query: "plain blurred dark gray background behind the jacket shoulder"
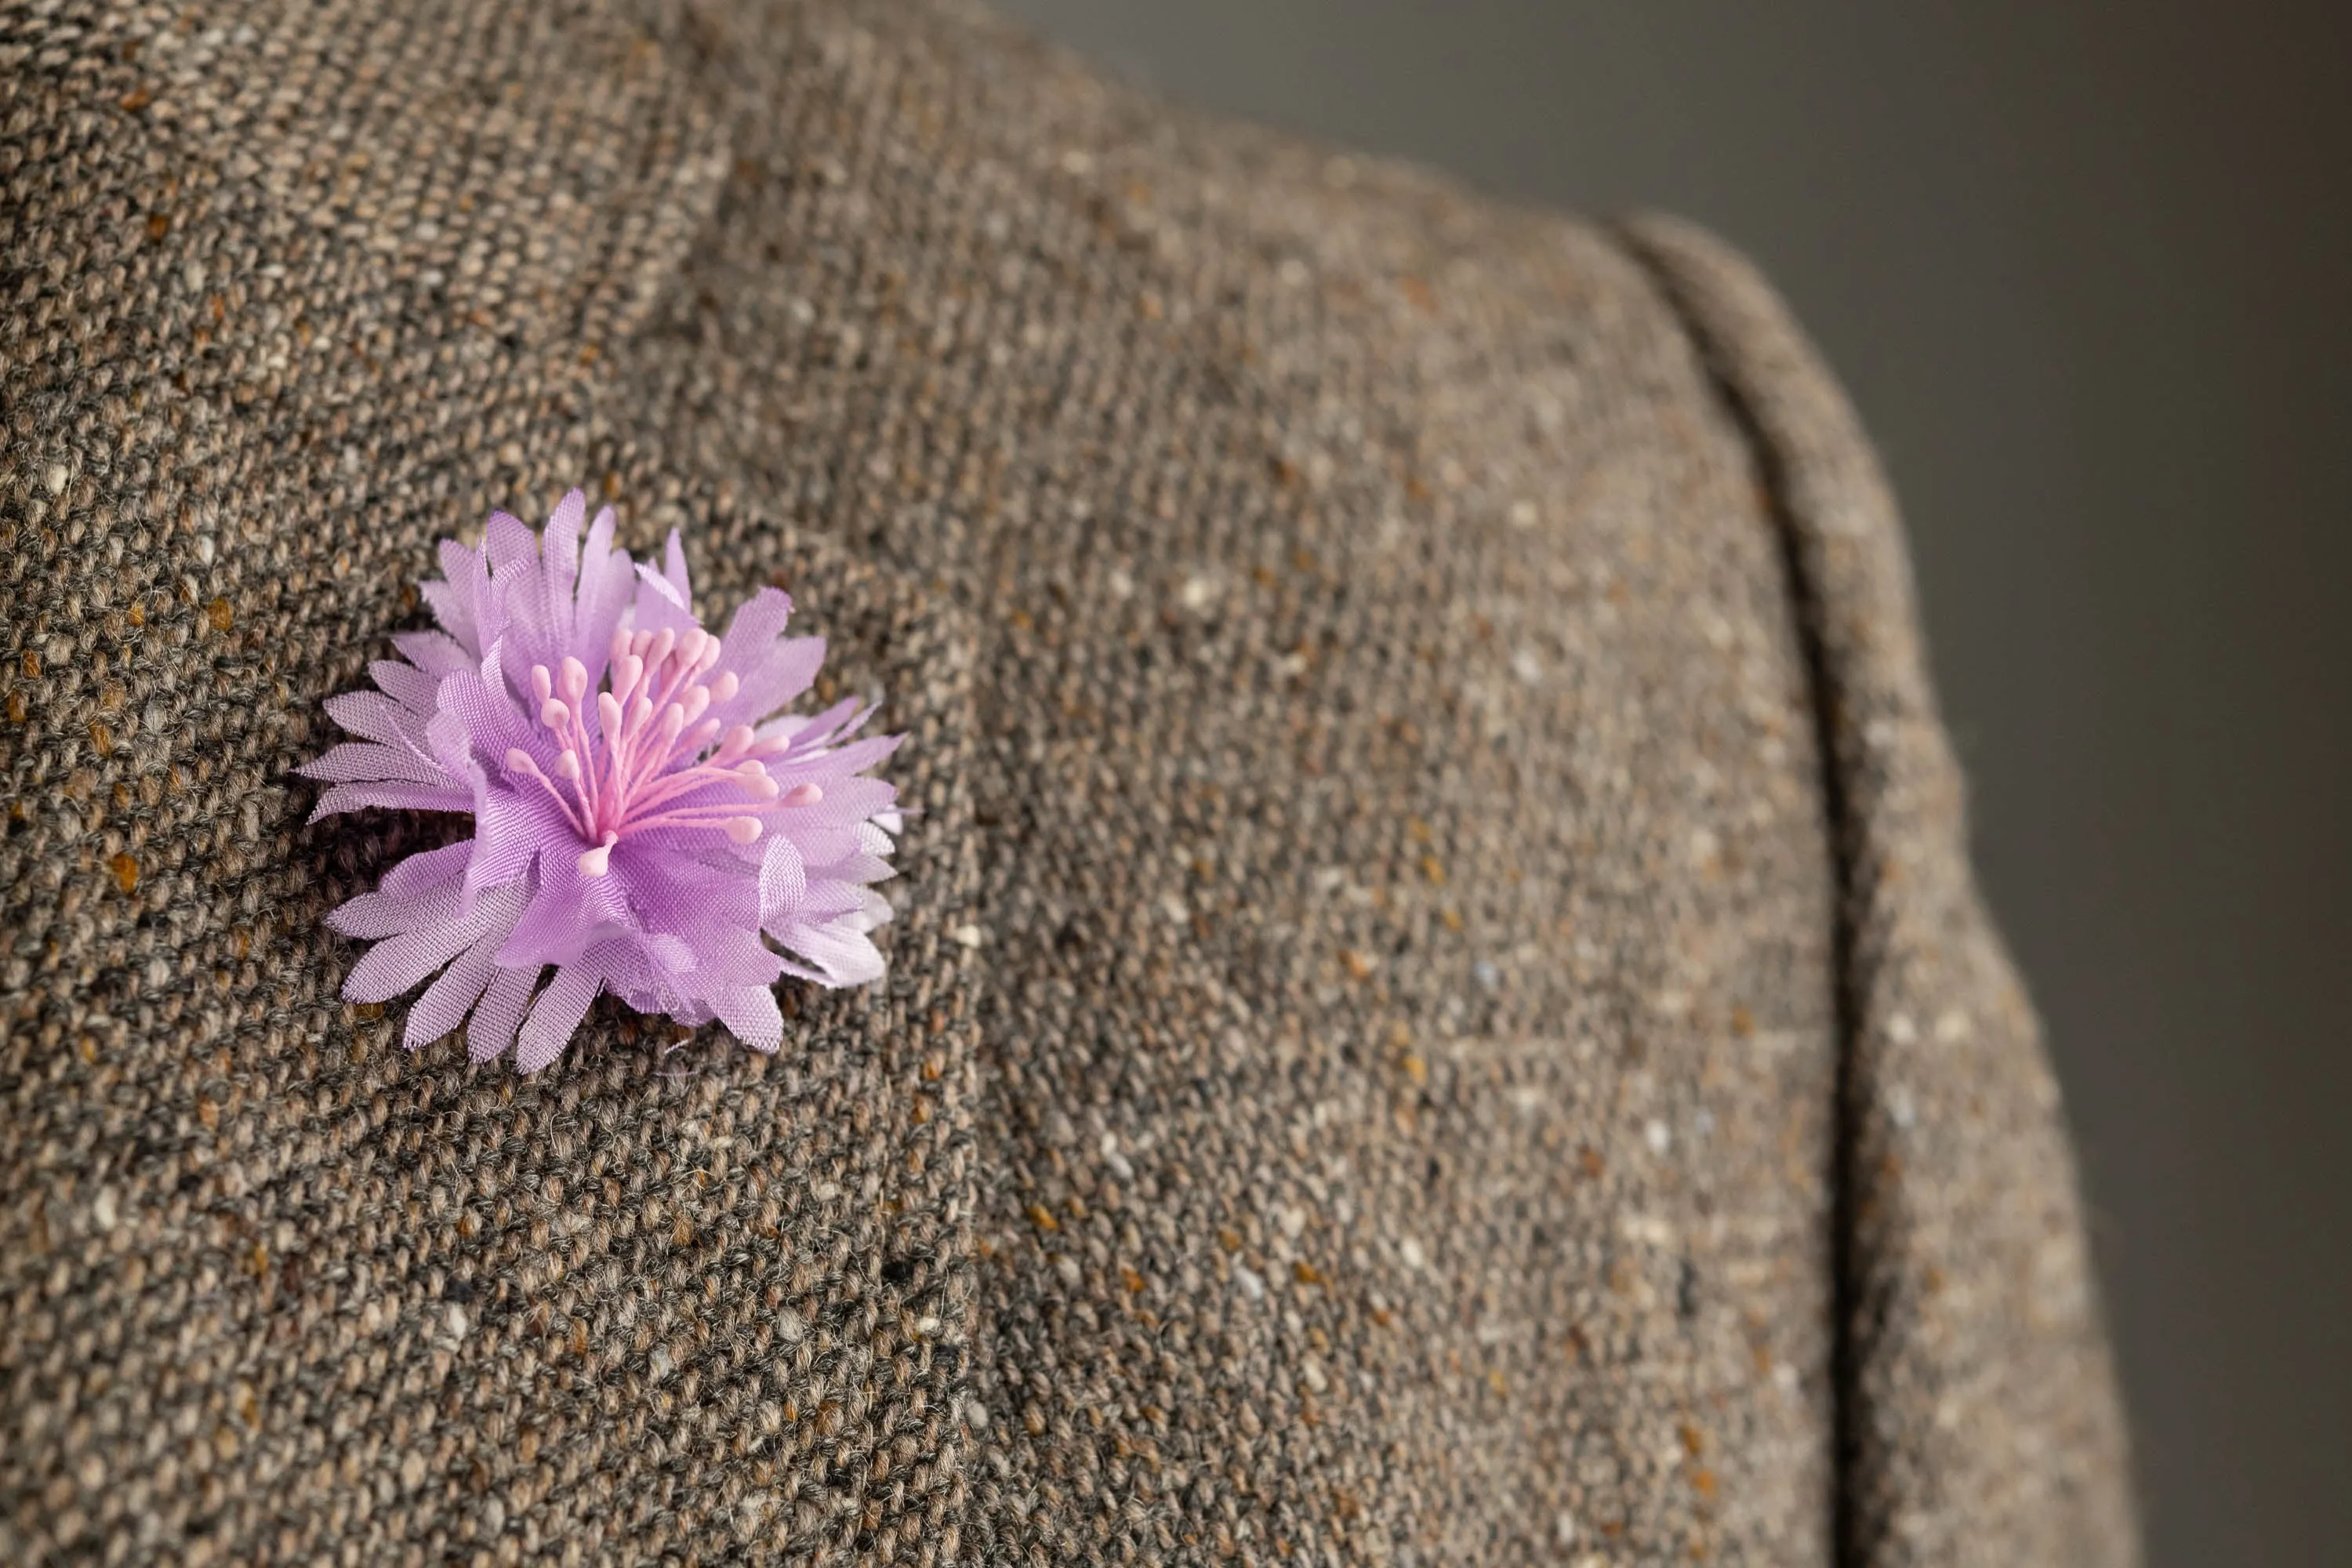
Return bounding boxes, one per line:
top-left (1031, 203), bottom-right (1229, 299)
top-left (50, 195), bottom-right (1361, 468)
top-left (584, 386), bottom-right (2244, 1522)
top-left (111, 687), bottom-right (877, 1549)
top-left (1000, 0), bottom-right (2352, 1568)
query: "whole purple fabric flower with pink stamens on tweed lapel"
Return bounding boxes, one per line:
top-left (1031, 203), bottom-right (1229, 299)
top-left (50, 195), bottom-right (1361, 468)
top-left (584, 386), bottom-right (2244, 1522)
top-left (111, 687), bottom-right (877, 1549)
top-left (301, 492), bottom-right (901, 1072)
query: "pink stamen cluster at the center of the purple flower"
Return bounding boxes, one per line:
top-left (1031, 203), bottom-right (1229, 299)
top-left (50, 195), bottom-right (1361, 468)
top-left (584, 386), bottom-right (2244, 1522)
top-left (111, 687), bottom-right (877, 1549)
top-left (506, 626), bottom-right (823, 877)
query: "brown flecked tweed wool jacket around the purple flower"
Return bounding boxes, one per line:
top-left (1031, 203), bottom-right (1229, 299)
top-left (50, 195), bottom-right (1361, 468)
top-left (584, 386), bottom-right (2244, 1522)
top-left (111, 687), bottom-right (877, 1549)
top-left (0, 0), bottom-right (2136, 1568)
